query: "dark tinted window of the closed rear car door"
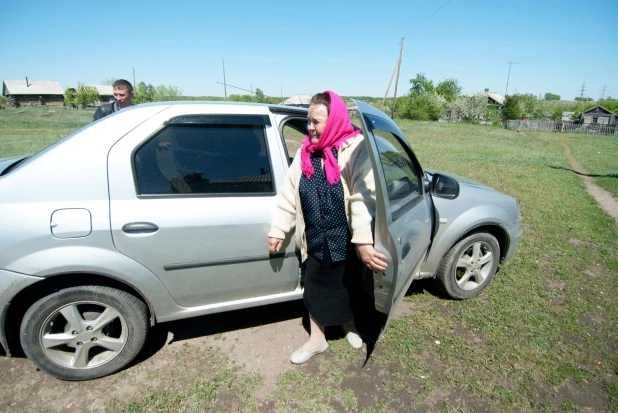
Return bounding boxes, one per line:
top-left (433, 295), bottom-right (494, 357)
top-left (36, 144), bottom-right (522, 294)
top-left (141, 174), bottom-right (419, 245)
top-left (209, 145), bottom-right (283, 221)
top-left (133, 122), bottom-right (274, 195)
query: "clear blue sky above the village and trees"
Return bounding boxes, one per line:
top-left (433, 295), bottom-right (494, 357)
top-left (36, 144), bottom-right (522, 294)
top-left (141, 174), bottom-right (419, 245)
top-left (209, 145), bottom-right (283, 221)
top-left (0, 0), bottom-right (618, 99)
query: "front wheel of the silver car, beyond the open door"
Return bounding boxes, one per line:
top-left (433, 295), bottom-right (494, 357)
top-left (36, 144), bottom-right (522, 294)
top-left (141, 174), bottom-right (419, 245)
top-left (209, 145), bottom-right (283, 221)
top-left (437, 232), bottom-right (500, 300)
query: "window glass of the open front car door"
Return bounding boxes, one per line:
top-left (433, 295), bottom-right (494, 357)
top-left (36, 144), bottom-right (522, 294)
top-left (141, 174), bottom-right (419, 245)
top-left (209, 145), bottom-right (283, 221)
top-left (372, 129), bottom-right (422, 220)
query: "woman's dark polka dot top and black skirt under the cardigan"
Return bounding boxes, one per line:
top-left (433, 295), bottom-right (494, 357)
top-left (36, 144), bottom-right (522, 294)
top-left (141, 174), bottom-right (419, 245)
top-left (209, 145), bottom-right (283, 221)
top-left (299, 148), bottom-right (360, 326)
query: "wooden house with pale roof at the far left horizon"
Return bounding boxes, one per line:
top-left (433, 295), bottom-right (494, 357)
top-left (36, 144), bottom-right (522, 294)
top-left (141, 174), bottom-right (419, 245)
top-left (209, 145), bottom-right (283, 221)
top-left (2, 78), bottom-right (64, 107)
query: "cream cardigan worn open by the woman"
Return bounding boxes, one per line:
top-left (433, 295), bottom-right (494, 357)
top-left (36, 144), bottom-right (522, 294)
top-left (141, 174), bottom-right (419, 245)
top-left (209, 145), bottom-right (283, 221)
top-left (268, 134), bottom-right (375, 261)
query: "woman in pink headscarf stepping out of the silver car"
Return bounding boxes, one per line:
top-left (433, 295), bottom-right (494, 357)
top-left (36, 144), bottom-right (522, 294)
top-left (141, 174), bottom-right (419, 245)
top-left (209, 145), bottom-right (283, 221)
top-left (268, 91), bottom-right (387, 364)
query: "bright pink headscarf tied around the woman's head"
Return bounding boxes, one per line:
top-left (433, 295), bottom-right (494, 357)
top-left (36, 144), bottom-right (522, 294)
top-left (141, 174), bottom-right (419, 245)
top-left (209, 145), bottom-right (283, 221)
top-left (300, 90), bottom-right (358, 185)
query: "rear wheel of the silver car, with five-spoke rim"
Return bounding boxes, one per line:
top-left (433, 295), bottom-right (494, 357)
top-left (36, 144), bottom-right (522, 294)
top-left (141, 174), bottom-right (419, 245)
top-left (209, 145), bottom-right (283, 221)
top-left (20, 286), bottom-right (148, 381)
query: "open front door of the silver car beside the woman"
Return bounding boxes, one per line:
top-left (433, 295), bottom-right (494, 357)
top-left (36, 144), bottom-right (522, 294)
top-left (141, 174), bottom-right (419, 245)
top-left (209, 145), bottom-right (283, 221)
top-left (354, 100), bottom-right (433, 337)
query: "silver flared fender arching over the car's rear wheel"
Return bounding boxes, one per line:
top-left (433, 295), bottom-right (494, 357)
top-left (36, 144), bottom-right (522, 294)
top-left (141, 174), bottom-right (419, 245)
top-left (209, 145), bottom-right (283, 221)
top-left (6, 246), bottom-right (179, 318)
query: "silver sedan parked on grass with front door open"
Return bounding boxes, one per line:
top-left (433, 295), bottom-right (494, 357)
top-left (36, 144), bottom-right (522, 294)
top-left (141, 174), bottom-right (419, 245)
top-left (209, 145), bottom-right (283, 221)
top-left (0, 102), bottom-right (521, 380)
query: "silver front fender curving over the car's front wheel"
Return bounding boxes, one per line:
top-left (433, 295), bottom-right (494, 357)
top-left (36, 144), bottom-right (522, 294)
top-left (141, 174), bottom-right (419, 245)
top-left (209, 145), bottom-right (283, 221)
top-left (419, 201), bottom-right (510, 278)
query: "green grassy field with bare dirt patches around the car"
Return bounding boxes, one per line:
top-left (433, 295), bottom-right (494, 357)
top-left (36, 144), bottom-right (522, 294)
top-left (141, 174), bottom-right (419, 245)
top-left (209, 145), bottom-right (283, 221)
top-left (0, 108), bottom-right (618, 413)
